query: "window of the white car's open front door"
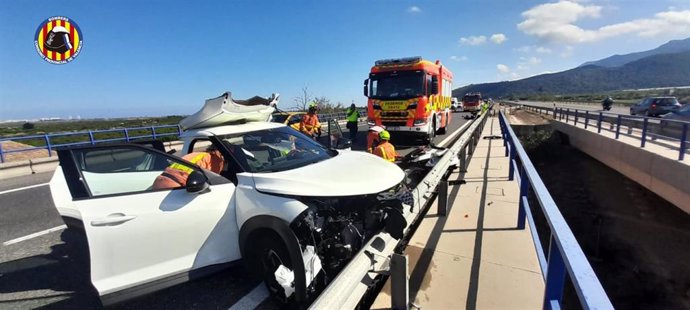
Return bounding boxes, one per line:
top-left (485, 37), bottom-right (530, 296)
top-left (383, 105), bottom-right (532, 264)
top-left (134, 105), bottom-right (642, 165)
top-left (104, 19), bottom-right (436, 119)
top-left (72, 146), bottom-right (198, 197)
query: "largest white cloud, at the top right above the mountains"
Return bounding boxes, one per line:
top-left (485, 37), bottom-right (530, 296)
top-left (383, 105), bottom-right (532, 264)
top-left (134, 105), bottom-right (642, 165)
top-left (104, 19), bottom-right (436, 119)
top-left (517, 0), bottom-right (690, 44)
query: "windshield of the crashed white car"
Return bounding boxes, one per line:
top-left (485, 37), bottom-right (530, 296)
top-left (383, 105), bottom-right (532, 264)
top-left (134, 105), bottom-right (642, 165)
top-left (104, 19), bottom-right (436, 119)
top-left (219, 127), bottom-right (337, 173)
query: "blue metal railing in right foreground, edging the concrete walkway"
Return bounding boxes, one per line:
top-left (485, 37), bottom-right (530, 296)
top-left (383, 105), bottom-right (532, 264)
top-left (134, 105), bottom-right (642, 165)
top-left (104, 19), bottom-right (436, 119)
top-left (499, 111), bottom-right (613, 309)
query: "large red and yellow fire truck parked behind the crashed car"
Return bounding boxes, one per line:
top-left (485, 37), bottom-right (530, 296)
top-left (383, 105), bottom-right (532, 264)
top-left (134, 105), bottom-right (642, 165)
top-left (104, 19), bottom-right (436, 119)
top-left (364, 56), bottom-right (453, 142)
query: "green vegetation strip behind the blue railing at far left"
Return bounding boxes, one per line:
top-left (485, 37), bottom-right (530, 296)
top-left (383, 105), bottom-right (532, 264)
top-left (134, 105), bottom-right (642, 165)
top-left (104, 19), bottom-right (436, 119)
top-left (0, 115), bottom-right (183, 146)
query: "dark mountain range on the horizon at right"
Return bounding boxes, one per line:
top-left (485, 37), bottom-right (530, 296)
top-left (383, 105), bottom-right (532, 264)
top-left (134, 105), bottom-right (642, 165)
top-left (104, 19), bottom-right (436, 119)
top-left (453, 38), bottom-right (690, 97)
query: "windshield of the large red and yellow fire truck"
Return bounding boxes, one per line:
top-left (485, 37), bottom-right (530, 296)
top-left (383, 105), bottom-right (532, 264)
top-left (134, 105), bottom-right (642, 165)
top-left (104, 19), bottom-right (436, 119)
top-left (370, 71), bottom-right (424, 100)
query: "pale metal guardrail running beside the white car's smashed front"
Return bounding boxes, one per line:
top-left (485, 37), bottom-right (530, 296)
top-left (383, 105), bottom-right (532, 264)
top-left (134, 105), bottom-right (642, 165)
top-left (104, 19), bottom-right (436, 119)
top-left (309, 108), bottom-right (488, 310)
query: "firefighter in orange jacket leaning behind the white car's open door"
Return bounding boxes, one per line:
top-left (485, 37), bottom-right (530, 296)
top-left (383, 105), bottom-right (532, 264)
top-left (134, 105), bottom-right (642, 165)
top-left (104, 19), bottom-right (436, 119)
top-left (153, 145), bottom-right (224, 189)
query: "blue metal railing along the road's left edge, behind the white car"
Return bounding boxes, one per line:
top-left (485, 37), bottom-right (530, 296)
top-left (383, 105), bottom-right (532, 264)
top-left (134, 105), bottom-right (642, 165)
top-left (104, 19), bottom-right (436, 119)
top-left (0, 125), bottom-right (182, 163)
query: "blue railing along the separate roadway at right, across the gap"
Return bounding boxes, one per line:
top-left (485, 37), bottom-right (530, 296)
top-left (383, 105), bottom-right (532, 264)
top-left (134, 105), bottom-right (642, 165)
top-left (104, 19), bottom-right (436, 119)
top-left (515, 104), bottom-right (690, 160)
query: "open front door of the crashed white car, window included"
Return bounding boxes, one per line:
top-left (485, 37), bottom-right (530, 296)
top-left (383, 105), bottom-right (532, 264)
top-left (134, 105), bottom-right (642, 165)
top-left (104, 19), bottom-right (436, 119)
top-left (50, 144), bottom-right (240, 303)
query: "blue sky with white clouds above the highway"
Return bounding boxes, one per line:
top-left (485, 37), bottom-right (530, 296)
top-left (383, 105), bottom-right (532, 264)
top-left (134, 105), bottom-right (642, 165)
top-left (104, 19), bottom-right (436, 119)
top-left (0, 0), bottom-right (690, 120)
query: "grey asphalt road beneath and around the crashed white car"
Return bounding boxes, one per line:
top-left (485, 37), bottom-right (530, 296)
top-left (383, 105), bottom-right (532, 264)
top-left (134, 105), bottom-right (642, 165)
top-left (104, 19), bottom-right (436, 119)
top-left (0, 113), bottom-right (467, 309)
